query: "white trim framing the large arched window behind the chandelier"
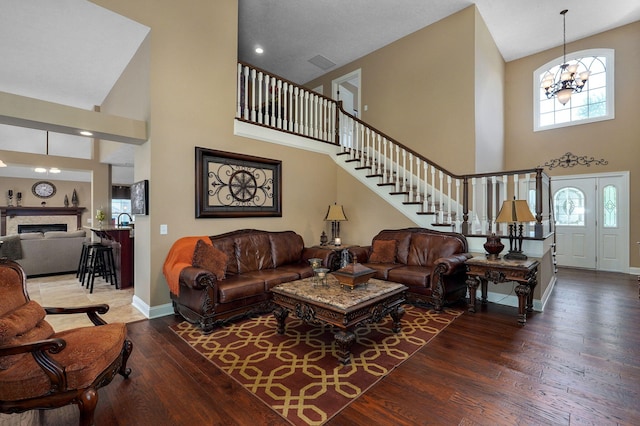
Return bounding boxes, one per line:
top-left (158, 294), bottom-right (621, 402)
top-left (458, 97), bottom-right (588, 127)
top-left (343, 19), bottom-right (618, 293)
top-left (532, 48), bottom-right (615, 132)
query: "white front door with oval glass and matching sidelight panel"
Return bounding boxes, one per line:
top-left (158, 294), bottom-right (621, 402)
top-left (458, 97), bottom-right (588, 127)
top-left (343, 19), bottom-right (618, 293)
top-left (552, 173), bottom-right (629, 272)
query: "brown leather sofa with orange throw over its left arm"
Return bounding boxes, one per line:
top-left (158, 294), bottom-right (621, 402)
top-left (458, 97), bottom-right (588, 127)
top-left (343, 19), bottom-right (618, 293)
top-left (163, 229), bottom-right (335, 333)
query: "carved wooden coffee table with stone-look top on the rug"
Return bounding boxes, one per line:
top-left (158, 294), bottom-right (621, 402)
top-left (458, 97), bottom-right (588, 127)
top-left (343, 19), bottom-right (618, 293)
top-left (271, 274), bottom-right (407, 365)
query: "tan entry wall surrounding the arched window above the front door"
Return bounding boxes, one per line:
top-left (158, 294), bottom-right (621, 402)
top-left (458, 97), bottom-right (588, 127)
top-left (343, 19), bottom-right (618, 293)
top-left (505, 22), bottom-right (640, 267)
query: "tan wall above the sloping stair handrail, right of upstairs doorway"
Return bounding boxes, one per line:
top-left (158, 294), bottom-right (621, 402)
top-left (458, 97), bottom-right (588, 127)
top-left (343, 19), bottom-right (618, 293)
top-left (306, 6), bottom-right (476, 174)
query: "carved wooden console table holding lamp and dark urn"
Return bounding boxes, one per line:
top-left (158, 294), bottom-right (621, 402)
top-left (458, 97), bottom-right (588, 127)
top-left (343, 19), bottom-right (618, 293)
top-left (465, 256), bottom-right (540, 325)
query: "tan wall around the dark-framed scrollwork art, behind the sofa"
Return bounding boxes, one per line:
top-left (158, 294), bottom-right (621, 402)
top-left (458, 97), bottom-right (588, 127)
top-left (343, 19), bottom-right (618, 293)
top-left (95, 0), bottom-right (337, 306)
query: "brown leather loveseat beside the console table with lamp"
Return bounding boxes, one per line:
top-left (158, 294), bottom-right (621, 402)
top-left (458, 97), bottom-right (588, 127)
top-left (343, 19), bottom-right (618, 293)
top-left (349, 228), bottom-right (471, 311)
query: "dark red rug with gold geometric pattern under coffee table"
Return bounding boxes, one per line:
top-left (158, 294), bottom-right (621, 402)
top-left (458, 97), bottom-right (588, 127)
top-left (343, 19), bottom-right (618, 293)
top-left (171, 305), bottom-right (462, 425)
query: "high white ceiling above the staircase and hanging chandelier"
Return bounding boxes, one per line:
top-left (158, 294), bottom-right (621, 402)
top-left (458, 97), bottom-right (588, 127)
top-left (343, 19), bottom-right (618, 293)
top-left (238, 0), bottom-right (640, 84)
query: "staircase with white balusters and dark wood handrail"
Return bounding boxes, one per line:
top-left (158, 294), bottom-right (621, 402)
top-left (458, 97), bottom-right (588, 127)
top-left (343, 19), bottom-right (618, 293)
top-left (236, 63), bottom-right (553, 239)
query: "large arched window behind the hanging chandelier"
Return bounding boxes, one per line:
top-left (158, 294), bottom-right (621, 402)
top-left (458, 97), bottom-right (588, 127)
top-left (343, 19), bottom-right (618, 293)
top-left (533, 49), bottom-right (614, 131)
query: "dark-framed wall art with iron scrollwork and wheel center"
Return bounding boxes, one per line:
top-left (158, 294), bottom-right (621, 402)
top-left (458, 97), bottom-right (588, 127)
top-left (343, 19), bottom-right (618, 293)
top-left (196, 147), bottom-right (282, 218)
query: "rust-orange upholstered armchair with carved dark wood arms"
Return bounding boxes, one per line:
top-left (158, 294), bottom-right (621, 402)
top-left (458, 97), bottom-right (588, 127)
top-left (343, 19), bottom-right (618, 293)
top-left (0, 258), bottom-right (132, 425)
